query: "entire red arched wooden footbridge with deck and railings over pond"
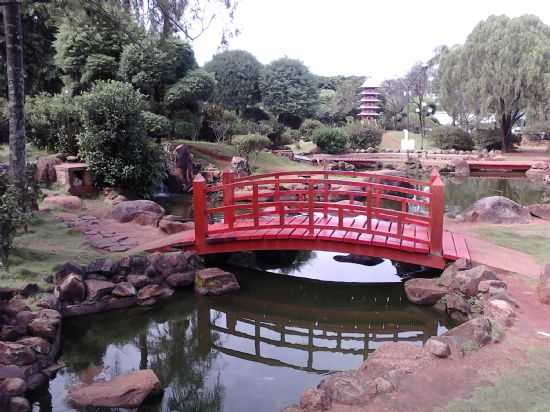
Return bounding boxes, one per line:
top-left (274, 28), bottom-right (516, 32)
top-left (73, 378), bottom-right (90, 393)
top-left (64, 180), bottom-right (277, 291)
top-left (146, 169), bottom-right (470, 268)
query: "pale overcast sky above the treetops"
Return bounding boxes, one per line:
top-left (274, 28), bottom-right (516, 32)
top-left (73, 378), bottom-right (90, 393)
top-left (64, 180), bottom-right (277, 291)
top-left (194, 0), bottom-right (550, 80)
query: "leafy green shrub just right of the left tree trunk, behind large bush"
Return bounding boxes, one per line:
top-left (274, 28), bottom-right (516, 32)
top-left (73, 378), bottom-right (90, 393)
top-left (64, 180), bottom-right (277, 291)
top-left (25, 94), bottom-right (82, 155)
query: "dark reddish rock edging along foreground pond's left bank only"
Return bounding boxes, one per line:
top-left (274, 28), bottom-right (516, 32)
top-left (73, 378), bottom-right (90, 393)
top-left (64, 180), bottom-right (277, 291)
top-left (0, 252), bottom-right (239, 412)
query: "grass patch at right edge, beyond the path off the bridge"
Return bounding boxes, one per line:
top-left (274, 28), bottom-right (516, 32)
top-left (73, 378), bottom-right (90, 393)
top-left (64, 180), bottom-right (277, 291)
top-left (477, 225), bottom-right (550, 263)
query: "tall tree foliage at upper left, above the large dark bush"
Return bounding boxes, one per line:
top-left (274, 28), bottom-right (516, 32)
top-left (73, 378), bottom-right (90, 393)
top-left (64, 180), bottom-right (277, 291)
top-left (54, 3), bottom-right (139, 94)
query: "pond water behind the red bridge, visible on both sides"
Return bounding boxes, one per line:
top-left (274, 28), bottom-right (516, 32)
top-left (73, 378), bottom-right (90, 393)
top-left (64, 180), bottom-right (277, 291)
top-left (156, 176), bottom-right (550, 218)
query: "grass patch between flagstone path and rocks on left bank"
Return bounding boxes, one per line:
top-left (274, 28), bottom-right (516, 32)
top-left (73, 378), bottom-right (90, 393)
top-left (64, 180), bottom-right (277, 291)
top-left (0, 213), bottom-right (104, 287)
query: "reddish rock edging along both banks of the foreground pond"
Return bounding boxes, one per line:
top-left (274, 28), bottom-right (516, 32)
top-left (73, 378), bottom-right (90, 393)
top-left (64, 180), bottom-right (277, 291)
top-left (0, 252), bottom-right (517, 412)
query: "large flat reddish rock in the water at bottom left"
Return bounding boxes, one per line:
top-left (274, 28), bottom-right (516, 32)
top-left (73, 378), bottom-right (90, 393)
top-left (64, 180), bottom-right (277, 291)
top-left (68, 369), bottom-right (161, 409)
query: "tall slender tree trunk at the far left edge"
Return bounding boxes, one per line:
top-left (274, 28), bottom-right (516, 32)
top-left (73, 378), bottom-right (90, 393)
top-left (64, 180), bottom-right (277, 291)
top-left (3, 0), bottom-right (27, 187)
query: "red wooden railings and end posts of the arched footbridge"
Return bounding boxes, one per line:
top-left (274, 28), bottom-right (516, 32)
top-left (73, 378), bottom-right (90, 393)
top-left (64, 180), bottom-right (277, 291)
top-left (193, 169), bottom-right (444, 254)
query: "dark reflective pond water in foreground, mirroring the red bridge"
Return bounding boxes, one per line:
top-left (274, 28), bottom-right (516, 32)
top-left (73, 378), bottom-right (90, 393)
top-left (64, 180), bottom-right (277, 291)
top-left (35, 252), bottom-right (452, 412)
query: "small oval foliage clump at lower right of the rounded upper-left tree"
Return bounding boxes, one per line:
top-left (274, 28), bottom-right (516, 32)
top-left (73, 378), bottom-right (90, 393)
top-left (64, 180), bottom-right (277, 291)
top-left (165, 69), bottom-right (216, 109)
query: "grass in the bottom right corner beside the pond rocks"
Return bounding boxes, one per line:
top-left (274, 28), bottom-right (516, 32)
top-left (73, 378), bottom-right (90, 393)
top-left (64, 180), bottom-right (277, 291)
top-left (436, 349), bottom-right (550, 412)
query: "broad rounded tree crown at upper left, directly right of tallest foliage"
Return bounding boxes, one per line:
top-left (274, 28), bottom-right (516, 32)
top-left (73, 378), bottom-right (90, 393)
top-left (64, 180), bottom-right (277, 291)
top-left (118, 38), bottom-right (197, 101)
